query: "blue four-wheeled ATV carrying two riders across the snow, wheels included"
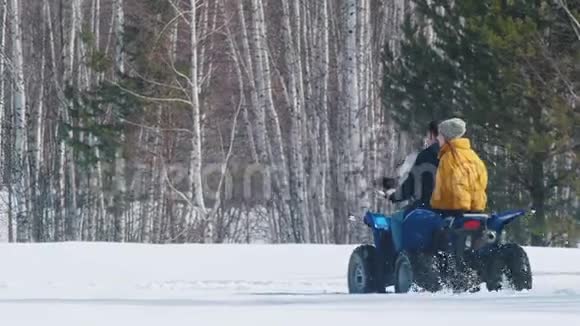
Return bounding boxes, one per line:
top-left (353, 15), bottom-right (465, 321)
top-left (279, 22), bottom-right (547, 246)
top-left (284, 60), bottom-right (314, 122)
top-left (348, 208), bottom-right (532, 293)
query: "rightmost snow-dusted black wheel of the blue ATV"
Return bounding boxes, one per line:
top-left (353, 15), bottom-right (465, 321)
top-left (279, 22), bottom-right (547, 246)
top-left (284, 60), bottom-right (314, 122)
top-left (486, 244), bottom-right (532, 291)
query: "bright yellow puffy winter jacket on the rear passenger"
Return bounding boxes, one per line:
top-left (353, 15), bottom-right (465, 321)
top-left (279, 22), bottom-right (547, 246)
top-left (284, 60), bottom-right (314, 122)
top-left (431, 138), bottom-right (487, 212)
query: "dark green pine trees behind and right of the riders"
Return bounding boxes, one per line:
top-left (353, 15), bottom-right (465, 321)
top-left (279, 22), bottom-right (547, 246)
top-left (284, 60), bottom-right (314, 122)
top-left (385, 0), bottom-right (580, 245)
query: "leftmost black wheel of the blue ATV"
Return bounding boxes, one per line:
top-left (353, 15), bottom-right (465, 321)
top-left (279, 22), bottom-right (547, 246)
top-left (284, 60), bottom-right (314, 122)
top-left (348, 245), bottom-right (384, 293)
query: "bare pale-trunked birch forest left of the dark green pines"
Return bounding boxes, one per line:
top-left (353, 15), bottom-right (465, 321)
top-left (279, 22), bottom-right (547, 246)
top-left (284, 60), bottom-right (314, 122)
top-left (0, 0), bottom-right (578, 243)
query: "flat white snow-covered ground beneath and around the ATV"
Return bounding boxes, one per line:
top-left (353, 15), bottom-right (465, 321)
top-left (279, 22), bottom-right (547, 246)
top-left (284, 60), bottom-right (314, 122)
top-left (0, 243), bottom-right (580, 326)
